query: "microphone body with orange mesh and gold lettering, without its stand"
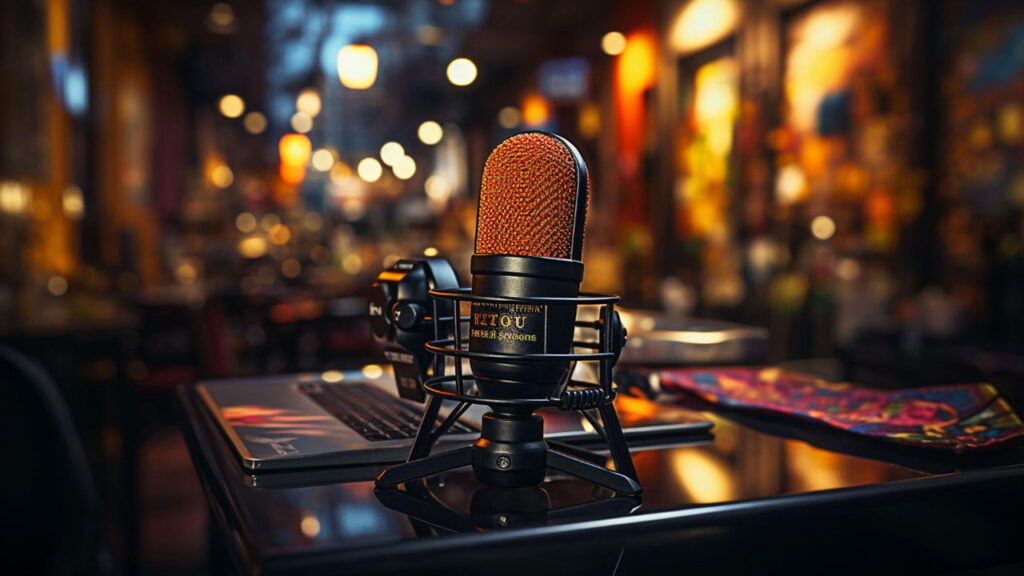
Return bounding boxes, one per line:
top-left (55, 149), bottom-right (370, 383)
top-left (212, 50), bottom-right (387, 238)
top-left (469, 131), bottom-right (590, 399)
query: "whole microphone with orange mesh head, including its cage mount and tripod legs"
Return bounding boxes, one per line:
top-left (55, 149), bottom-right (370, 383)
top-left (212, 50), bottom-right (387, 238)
top-left (377, 132), bottom-right (641, 494)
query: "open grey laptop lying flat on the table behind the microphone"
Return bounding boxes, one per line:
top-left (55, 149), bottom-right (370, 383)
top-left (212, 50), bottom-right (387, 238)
top-left (197, 364), bottom-right (713, 471)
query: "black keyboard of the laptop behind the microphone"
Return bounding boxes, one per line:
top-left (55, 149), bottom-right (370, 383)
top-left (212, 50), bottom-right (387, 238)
top-left (300, 382), bottom-right (476, 440)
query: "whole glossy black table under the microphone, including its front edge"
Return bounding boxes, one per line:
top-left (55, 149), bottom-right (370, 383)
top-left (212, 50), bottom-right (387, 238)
top-left (179, 381), bottom-right (1024, 575)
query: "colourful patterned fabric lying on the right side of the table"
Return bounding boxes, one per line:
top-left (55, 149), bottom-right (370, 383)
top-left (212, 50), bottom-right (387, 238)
top-left (658, 368), bottom-right (1024, 452)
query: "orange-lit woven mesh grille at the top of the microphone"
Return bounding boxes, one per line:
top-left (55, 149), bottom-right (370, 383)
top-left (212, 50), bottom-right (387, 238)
top-left (475, 132), bottom-right (590, 259)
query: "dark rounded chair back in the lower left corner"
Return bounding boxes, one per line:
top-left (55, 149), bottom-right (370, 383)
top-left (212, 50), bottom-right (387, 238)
top-left (0, 345), bottom-right (111, 575)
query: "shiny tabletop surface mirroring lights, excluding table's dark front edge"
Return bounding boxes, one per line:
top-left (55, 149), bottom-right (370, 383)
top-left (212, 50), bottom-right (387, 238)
top-left (217, 413), bottom-right (927, 548)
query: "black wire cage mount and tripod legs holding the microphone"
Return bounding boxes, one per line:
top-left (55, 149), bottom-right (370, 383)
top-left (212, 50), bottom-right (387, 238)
top-left (377, 288), bottom-right (642, 494)
